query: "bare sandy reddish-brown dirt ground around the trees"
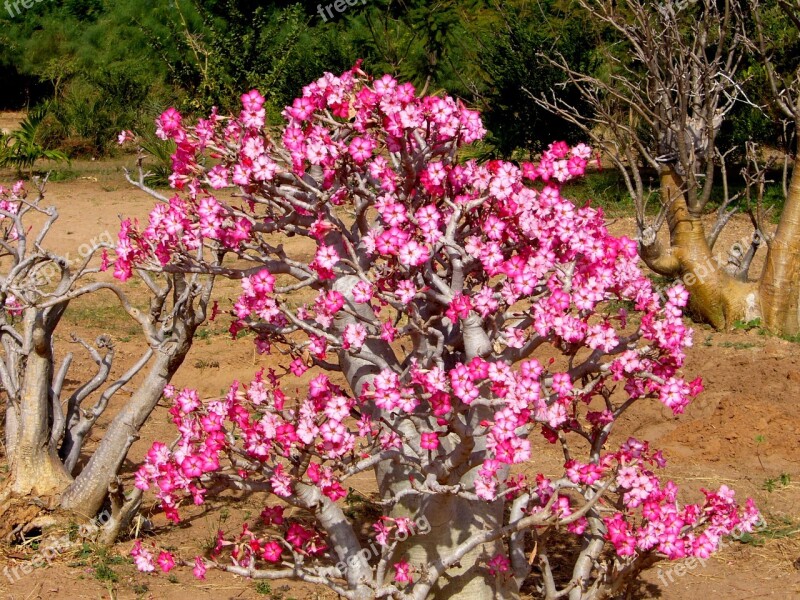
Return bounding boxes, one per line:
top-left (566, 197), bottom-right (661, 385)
top-left (0, 159), bottom-right (800, 600)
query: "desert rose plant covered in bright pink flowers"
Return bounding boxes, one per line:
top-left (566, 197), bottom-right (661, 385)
top-left (122, 67), bottom-right (758, 600)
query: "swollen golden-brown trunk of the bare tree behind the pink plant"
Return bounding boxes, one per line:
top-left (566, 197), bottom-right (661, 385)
top-left (640, 169), bottom-right (760, 329)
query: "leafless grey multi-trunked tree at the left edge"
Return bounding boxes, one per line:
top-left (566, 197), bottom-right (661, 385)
top-left (0, 172), bottom-right (213, 540)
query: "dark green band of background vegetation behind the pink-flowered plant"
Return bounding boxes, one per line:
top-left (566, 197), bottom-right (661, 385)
top-left (0, 0), bottom-right (791, 163)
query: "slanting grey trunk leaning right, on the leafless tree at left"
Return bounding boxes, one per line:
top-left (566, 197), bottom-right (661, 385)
top-left (61, 326), bottom-right (194, 518)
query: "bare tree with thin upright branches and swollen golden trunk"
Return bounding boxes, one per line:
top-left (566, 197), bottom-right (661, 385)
top-left (538, 0), bottom-right (784, 332)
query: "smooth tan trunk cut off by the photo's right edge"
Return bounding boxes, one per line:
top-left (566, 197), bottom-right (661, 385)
top-left (759, 154), bottom-right (800, 335)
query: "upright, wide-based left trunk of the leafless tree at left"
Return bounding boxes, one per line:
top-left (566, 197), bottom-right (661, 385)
top-left (11, 308), bottom-right (72, 497)
